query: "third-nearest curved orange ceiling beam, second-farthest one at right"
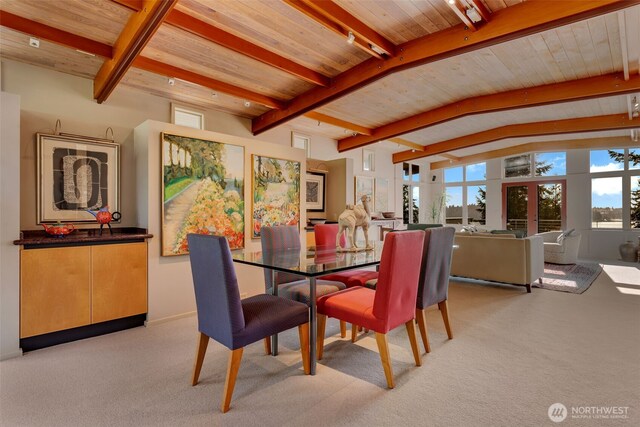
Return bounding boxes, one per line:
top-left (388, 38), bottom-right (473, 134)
top-left (393, 114), bottom-right (640, 163)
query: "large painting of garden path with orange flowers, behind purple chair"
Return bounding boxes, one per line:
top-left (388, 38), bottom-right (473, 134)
top-left (160, 133), bottom-right (244, 256)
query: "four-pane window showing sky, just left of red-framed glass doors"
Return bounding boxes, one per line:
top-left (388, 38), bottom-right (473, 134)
top-left (444, 163), bottom-right (487, 224)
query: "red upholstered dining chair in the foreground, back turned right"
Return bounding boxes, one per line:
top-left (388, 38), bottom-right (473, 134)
top-left (317, 231), bottom-right (424, 388)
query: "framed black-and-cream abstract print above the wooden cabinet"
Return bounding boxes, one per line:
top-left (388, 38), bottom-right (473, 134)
top-left (36, 133), bottom-right (120, 224)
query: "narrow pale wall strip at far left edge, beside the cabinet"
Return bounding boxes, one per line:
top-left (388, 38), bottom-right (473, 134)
top-left (0, 92), bottom-right (22, 360)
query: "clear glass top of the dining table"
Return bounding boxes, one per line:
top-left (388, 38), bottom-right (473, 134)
top-left (232, 242), bottom-right (383, 277)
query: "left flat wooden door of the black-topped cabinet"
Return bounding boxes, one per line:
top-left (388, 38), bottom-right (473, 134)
top-left (20, 246), bottom-right (91, 338)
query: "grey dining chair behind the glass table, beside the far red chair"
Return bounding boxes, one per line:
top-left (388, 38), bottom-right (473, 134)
top-left (260, 225), bottom-right (347, 340)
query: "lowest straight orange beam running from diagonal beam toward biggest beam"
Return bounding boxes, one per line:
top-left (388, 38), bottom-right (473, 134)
top-left (133, 56), bottom-right (285, 108)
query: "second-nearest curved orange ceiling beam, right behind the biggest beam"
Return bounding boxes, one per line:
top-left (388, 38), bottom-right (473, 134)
top-left (338, 73), bottom-right (640, 152)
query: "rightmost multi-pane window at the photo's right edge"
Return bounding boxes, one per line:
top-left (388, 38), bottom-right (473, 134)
top-left (589, 148), bottom-right (640, 229)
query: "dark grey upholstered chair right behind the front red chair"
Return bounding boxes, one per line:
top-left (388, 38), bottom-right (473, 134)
top-left (416, 227), bottom-right (455, 353)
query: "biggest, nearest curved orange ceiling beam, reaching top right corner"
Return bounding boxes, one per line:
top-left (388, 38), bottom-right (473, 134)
top-left (252, 0), bottom-right (640, 135)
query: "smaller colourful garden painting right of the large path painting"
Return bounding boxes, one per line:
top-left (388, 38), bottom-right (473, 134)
top-left (251, 154), bottom-right (300, 238)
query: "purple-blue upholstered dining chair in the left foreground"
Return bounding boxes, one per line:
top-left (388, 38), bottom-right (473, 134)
top-left (187, 234), bottom-right (310, 412)
